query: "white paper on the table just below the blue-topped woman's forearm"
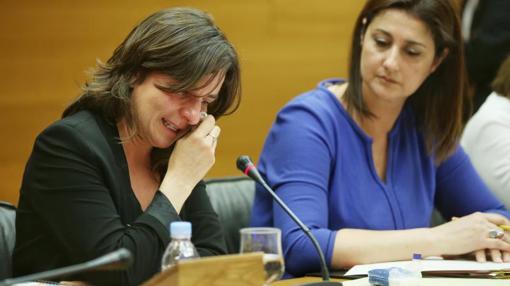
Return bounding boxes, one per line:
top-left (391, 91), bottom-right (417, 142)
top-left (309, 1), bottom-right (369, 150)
top-left (345, 259), bottom-right (510, 276)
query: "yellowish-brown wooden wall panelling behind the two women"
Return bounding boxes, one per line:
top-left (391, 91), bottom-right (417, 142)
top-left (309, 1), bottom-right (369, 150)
top-left (0, 0), bottom-right (364, 203)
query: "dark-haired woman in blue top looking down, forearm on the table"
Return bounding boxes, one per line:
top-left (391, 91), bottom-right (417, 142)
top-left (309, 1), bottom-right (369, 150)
top-left (252, 0), bottom-right (510, 275)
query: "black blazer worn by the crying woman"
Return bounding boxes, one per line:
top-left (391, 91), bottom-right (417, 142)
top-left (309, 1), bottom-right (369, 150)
top-left (13, 111), bottom-right (226, 285)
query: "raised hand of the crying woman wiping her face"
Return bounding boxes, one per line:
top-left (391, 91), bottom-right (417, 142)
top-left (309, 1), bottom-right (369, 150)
top-left (160, 115), bottom-right (221, 212)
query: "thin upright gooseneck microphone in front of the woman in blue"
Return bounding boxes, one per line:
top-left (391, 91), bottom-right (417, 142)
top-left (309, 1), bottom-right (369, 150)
top-left (236, 155), bottom-right (342, 286)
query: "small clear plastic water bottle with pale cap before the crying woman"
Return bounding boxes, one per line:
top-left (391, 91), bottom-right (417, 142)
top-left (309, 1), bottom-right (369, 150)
top-left (161, 221), bottom-right (199, 271)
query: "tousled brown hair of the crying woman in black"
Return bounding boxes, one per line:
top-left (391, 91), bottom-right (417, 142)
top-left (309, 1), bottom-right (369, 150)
top-left (62, 8), bottom-right (241, 178)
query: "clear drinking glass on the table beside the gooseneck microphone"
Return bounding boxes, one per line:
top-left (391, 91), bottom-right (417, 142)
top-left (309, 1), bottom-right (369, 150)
top-left (240, 227), bottom-right (285, 285)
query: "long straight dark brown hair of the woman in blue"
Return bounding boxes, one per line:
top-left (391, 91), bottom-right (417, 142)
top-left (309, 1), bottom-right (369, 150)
top-left (344, 0), bottom-right (465, 163)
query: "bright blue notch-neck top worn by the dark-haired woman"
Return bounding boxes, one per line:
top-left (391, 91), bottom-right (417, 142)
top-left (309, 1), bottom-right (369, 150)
top-left (251, 79), bottom-right (510, 276)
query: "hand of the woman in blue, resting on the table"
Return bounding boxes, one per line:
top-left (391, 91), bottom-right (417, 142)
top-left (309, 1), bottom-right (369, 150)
top-left (433, 212), bottom-right (510, 262)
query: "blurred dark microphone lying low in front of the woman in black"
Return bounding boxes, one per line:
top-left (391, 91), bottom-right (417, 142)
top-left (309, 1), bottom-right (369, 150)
top-left (0, 248), bottom-right (133, 286)
